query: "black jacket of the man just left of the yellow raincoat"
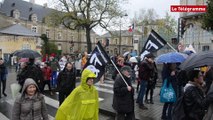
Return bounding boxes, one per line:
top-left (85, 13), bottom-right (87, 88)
top-left (58, 68), bottom-right (76, 92)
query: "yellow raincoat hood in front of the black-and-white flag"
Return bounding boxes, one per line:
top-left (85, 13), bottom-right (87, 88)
top-left (81, 69), bottom-right (96, 89)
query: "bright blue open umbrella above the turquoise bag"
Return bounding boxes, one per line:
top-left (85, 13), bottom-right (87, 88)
top-left (155, 52), bottom-right (188, 64)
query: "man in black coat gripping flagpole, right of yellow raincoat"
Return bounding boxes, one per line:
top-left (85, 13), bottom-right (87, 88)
top-left (112, 66), bottom-right (135, 120)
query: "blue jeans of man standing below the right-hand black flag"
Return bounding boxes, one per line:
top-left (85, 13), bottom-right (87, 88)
top-left (137, 80), bottom-right (148, 105)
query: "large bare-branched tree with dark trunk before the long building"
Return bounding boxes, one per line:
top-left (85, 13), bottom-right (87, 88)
top-left (47, 0), bottom-right (126, 52)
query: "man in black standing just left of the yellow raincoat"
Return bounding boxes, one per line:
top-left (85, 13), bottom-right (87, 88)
top-left (58, 62), bottom-right (76, 105)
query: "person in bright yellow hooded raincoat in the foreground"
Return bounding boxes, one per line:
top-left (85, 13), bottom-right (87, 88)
top-left (55, 69), bottom-right (99, 120)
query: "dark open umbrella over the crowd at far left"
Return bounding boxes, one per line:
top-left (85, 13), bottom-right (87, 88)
top-left (13, 49), bottom-right (41, 58)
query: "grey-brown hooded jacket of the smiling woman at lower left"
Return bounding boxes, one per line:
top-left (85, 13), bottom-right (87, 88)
top-left (11, 78), bottom-right (48, 120)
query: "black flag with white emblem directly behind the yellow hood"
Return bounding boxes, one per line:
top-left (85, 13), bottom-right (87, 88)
top-left (84, 42), bottom-right (110, 83)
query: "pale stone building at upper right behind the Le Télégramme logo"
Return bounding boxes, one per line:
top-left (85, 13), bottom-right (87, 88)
top-left (179, 0), bottom-right (213, 52)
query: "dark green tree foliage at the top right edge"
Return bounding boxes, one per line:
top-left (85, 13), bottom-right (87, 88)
top-left (202, 0), bottom-right (213, 29)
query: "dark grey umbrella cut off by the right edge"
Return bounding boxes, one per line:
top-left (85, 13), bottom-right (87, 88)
top-left (180, 51), bottom-right (213, 70)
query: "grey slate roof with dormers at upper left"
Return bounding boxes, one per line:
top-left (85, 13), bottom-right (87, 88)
top-left (0, 0), bottom-right (53, 21)
